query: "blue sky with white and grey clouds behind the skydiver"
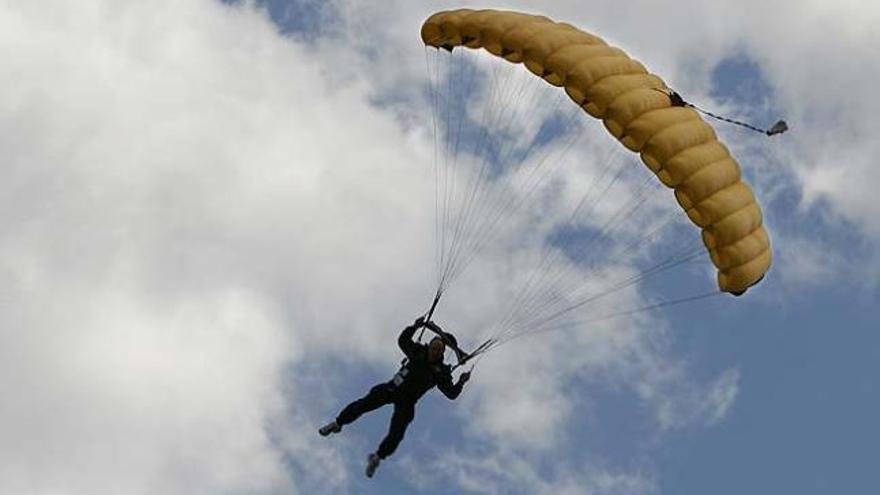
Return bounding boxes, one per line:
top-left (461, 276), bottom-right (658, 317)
top-left (0, 0), bottom-right (880, 495)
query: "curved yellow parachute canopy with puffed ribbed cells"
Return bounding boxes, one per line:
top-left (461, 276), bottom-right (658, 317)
top-left (421, 9), bottom-right (772, 295)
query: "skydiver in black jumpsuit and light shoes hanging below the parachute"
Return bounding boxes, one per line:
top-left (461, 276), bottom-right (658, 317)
top-left (318, 318), bottom-right (470, 477)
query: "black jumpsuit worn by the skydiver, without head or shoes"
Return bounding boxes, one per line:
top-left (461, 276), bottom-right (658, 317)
top-left (336, 325), bottom-right (463, 459)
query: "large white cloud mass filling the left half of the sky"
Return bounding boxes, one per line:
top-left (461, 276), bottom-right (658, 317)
top-left (0, 2), bottom-right (429, 494)
